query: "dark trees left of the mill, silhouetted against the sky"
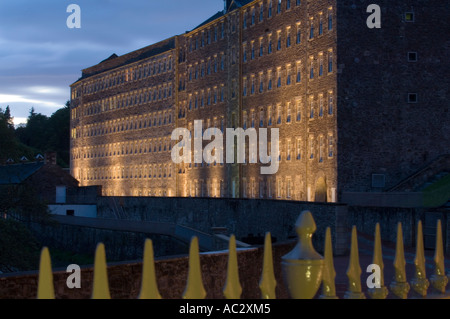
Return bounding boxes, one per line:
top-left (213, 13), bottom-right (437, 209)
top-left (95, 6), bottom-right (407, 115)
top-left (0, 101), bottom-right (70, 167)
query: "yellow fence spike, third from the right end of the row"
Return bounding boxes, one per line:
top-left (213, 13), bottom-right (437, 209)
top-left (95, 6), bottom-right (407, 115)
top-left (390, 223), bottom-right (410, 299)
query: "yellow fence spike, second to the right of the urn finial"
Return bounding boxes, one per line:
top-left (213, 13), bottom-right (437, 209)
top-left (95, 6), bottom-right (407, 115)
top-left (344, 226), bottom-right (366, 299)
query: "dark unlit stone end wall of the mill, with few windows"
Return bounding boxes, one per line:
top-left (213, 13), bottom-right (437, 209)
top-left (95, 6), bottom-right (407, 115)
top-left (337, 0), bottom-right (450, 192)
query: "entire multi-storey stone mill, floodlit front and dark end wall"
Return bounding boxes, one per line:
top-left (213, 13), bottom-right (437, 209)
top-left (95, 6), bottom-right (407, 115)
top-left (71, 0), bottom-right (450, 202)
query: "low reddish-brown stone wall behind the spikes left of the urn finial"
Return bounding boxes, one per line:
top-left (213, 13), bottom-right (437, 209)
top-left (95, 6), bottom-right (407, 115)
top-left (0, 243), bottom-right (293, 299)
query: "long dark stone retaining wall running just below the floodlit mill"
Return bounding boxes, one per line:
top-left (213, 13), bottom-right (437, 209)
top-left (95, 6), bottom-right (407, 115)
top-left (97, 197), bottom-right (349, 254)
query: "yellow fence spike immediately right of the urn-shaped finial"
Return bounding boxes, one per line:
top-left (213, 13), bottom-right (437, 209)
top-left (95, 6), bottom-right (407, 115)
top-left (320, 227), bottom-right (338, 299)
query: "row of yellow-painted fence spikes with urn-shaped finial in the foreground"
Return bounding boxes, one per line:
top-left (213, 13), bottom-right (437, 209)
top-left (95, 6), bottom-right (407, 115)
top-left (37, 211), bottom-right (448, 299)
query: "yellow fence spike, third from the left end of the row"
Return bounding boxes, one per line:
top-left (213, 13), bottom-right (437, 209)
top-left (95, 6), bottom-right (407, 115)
top-left (139, 239), bottom-right (161, 299)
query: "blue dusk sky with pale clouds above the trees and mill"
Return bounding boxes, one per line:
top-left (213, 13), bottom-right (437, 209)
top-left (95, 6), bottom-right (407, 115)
top-left (0, 0), bottom-right (223, 124)
